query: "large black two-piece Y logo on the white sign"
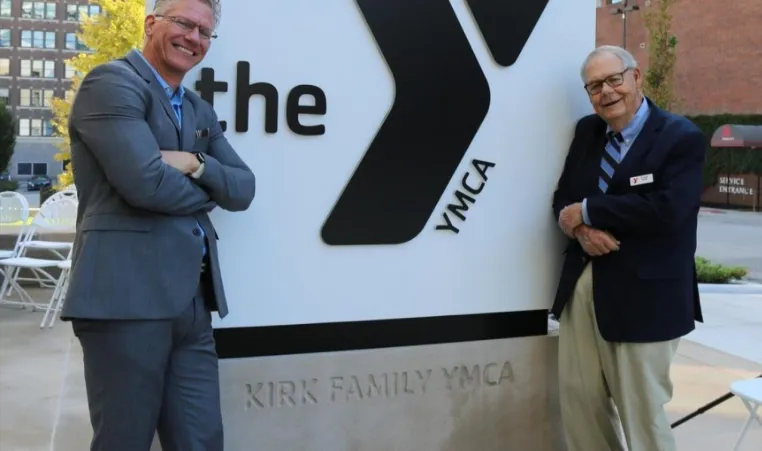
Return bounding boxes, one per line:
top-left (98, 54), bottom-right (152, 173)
top-left (322, 0), bottom-right (548, 245)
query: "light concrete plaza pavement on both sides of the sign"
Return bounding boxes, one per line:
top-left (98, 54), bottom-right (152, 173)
top-left (0, 290), bottom-right (762, 451)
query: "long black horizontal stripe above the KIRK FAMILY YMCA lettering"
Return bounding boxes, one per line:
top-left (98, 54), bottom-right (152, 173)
top-left (214, 310), bottom-right (548, 359)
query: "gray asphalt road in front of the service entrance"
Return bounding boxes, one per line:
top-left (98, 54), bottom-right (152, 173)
top-left (696, 209), bottom-right (762, 282)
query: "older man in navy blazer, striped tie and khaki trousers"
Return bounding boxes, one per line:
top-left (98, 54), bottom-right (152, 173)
top-left (552, 46), bottom-right (706, 451)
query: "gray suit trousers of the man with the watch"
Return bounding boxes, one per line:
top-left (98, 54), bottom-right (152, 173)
top-left (72, 276), bottom-right (223, 451)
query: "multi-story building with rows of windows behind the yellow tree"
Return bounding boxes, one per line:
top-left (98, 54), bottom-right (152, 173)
top-left (0, 0), bottom-right (100, 180)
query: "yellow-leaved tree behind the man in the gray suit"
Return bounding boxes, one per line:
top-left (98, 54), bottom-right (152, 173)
top-left (52, 0), bottom-right (145, 187)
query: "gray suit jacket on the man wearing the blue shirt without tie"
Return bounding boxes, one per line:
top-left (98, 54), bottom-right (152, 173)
top-left (61, 51), bottom-right (255, 320)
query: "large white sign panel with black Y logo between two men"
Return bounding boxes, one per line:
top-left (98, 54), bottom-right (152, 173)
top-left (160, 0), bottom-right (595, 328)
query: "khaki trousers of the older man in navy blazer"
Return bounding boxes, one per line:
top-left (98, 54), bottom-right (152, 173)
top-left (558, 264), bottom-right (680, 451)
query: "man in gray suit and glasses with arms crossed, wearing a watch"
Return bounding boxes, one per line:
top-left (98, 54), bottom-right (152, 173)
top-left (62, 0), bottom-right (255, 451)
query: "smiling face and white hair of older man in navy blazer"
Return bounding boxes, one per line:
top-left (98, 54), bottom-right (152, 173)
top-left (585, 53), bottom-right (643, 131)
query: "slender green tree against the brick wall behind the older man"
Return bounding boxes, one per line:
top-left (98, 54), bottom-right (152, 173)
top-left (643, 0), bottom-right (677, 110)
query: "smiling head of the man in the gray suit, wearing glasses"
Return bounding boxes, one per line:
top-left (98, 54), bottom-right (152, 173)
top-left (143, 0), bottom-right (214, 85)
